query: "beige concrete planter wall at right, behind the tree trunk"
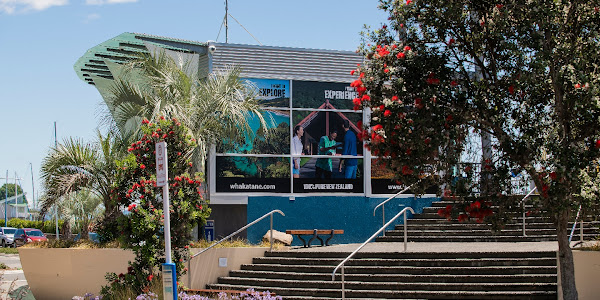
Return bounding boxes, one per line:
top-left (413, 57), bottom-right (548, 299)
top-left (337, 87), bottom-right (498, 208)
top-left (558, 250), bottom-right (600, 300)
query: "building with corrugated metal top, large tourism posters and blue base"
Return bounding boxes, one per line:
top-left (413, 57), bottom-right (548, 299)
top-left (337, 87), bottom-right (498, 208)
top-left (75, 33), bottom-right (434, 242)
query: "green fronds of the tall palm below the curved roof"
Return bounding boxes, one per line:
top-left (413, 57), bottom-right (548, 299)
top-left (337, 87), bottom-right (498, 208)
top-left (104, 51), bottom-right (268, 169)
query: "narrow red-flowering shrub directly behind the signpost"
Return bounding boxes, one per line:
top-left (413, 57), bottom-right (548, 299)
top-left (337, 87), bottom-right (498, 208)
top-left (101, 119), bottom-right (210, 292)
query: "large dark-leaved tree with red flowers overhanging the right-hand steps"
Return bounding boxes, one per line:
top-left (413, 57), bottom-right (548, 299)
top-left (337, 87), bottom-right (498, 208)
top-left (352, 0), bottom-right (600, 299)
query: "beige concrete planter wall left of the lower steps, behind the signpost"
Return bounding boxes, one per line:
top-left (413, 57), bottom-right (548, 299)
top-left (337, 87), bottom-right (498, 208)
top-left (19, 247), bottom-right (269, 300)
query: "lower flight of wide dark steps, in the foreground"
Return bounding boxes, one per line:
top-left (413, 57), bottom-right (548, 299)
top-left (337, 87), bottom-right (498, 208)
top-left (207, 248), bottom-right (557, 300)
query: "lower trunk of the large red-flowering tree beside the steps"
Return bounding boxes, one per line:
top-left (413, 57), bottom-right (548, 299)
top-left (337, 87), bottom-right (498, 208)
top-left (556, 210), bottom-right (578, 300)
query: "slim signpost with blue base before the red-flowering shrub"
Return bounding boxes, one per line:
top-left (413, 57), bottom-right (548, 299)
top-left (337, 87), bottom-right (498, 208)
top-left (156, 142), bottom-right (177, 300)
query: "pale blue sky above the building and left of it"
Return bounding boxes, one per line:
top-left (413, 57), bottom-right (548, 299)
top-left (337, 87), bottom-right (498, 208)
top-left (0, 0), bottom-right (387, 210)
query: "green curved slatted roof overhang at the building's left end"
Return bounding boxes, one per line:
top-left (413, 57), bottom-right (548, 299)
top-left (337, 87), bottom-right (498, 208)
top-left (73, 32), bottom-right (207, 84)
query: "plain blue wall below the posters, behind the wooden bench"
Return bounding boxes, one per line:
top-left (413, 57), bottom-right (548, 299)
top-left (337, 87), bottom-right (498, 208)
top-left (247, 196), bottom-right (439, 246)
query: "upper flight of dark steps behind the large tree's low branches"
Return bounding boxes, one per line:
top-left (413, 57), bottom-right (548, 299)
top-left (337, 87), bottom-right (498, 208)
top-left (377, 201), bottom-right (600, 243)
